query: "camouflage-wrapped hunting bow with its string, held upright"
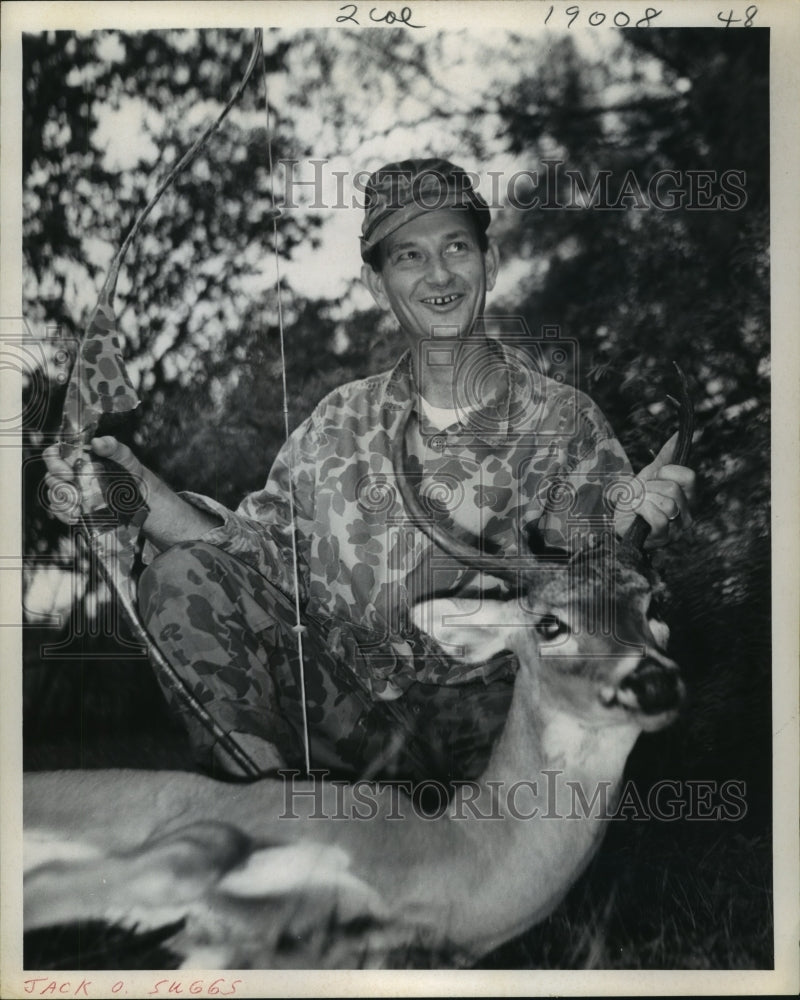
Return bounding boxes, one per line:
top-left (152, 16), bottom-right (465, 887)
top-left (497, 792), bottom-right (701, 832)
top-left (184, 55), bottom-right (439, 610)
top-left (58, 29), bottom-right (310, 778)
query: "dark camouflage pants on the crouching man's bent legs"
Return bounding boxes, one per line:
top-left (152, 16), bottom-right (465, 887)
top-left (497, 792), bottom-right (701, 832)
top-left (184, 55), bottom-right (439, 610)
top-left (139, 542), bottom-right (513, 782)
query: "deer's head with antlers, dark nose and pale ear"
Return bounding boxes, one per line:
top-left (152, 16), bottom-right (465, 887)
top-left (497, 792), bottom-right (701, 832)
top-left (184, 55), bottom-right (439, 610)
top-left (394, 365), bottom-right (693, 730)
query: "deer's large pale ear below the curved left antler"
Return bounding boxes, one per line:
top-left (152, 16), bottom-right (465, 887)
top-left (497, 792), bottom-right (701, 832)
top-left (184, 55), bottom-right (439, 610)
top-left (411, 597), bottom-right (522, 663)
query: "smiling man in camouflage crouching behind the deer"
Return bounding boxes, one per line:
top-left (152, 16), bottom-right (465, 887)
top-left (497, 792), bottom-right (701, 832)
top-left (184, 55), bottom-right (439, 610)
top-left (46, 159), bottom-right (694, 780)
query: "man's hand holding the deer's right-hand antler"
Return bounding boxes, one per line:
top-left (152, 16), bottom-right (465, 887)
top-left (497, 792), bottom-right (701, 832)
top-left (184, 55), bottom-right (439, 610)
top-left (614, 433), bottom-right (695, 549)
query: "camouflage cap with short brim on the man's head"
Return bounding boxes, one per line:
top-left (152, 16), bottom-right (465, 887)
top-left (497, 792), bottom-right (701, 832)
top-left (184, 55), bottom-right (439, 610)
top-left (361, 157), bottom-right (491, 262)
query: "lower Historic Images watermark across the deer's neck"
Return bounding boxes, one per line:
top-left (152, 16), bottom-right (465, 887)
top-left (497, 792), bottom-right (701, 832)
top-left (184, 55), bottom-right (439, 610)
top-left (279, 769), bottom-right (747, 823)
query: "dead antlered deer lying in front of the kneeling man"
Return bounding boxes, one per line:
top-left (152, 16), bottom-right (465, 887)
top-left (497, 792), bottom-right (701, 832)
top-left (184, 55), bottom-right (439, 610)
top-left (24, 379), bottom-right (692, 968)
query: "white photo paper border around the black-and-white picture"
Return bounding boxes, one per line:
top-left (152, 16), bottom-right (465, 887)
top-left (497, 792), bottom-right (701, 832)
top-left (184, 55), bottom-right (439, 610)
top-left (0, 0), bottom-right (800, 998)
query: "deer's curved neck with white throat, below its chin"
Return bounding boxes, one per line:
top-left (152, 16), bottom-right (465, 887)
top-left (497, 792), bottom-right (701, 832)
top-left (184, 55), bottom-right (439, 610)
top-left (404, 666), bottom-right (638, 954)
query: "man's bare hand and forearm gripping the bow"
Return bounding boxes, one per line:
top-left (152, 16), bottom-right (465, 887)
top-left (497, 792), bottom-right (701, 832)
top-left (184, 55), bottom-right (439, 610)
top-left (42, 436), bottom-right (220, 548)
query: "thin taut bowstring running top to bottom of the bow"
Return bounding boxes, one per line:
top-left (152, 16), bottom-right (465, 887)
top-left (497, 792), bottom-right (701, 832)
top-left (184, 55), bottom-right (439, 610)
top-left (257, 28), bottom-right (311, 775)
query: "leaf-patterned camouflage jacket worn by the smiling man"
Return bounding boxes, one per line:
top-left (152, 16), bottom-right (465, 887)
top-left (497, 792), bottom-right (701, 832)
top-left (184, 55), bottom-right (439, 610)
top-left (184, 344), bottom-right (630, 698)
